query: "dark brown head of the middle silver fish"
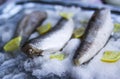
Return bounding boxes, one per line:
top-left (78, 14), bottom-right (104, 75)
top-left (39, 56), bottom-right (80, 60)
top-left (22, 44), bottom-right (43, 58)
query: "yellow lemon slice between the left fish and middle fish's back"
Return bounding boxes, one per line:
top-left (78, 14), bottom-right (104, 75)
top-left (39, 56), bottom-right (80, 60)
top-left (37, 23), bottom-right (52, 34)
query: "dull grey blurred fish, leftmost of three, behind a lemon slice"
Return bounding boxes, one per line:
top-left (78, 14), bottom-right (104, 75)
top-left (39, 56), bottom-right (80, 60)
top-left (15, 11), bottom-right (47, 46)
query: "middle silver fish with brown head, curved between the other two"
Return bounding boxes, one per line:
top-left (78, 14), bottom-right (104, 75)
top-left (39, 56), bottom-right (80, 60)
top-left (22, 18), bottom-right (74, 57)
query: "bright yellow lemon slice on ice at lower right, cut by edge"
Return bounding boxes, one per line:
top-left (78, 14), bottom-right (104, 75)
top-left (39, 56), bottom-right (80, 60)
top-left (101, 51), bottom-right (120, 63)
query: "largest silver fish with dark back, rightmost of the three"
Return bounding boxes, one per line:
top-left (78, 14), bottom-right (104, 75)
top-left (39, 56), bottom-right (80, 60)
top-left (73, 8), bottom-right (113, 65)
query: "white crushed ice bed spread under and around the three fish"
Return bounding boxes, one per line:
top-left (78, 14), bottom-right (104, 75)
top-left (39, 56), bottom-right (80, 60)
top-left (0, 4), bottom-right (120, 79)
